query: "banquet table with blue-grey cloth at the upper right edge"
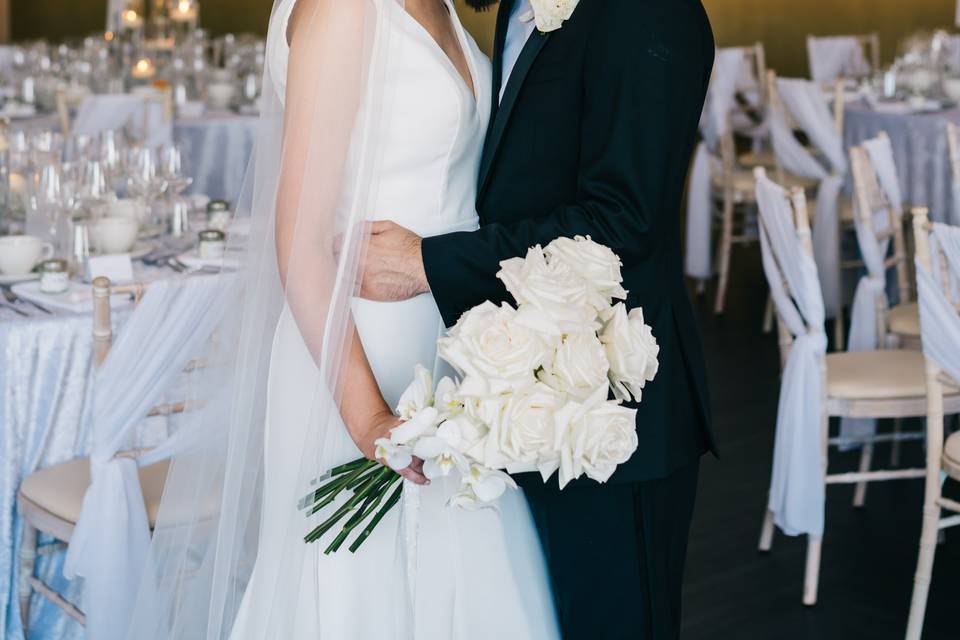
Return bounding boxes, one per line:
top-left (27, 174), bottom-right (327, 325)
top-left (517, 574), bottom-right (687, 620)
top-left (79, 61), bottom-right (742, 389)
top-left (844, 101), bottom-right (960, 222)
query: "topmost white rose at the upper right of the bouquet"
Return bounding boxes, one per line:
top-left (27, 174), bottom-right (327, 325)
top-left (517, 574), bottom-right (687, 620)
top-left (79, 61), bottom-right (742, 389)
top-left (543, 236), bottom-right (627, 313)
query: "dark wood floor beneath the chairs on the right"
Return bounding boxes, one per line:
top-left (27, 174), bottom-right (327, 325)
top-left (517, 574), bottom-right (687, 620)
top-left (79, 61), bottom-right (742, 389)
top-left (682, 249), bottom-right (960, 640)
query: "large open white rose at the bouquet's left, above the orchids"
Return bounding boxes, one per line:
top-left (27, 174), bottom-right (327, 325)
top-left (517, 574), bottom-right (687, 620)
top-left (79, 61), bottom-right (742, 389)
top-left (437, 302), bottom-right (549, 396)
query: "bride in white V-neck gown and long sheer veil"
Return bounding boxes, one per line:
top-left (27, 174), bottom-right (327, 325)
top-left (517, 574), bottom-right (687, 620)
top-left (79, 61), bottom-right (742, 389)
top-left (130, 0), bottom-right (558, 640)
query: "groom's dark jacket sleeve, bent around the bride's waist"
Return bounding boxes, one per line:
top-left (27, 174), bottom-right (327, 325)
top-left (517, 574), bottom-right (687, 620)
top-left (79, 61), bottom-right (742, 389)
top-left (422, 0), bottom-right (713, 326)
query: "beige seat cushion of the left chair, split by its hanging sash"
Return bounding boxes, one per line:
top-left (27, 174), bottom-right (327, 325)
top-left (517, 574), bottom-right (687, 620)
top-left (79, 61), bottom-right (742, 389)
top-left (20, 458), bottom-right (170, 529)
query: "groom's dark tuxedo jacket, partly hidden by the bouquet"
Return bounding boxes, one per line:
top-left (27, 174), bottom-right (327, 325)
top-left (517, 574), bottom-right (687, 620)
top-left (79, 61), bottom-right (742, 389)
top-left (422, 0), bottom-right (715, 482)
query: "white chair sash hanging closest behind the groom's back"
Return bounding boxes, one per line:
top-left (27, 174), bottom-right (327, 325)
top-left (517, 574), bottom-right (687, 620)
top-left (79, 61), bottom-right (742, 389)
top-left (685, 49), bottom-right (744, 280)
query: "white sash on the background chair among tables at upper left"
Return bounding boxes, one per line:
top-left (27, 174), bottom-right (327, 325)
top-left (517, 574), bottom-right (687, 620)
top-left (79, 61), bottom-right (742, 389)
top-left (72, 94), bottom-right (173, 147)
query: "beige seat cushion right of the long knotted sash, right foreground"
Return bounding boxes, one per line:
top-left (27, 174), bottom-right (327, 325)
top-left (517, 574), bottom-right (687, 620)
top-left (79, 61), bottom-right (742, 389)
top-left (827, 349), bottom-right (957, 400)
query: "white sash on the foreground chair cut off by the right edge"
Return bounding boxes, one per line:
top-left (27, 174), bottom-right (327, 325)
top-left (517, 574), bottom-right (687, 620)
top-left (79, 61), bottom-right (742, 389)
top-left (916, 224), bottom-right (960, 380)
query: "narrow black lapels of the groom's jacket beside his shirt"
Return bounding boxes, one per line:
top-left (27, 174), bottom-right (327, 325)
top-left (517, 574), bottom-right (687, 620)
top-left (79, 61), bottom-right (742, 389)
top-left (477, 11), bottom-right (550, 202)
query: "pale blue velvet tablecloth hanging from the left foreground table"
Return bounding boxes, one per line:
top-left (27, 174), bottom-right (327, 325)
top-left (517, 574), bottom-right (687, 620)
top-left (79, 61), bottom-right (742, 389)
top-left (0, 264), bottom-right (223, 640)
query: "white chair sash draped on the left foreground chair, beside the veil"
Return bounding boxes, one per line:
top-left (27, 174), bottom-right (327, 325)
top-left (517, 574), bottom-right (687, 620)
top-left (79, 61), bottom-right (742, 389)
top-left (63, 278), bottom-right (229, 640)
